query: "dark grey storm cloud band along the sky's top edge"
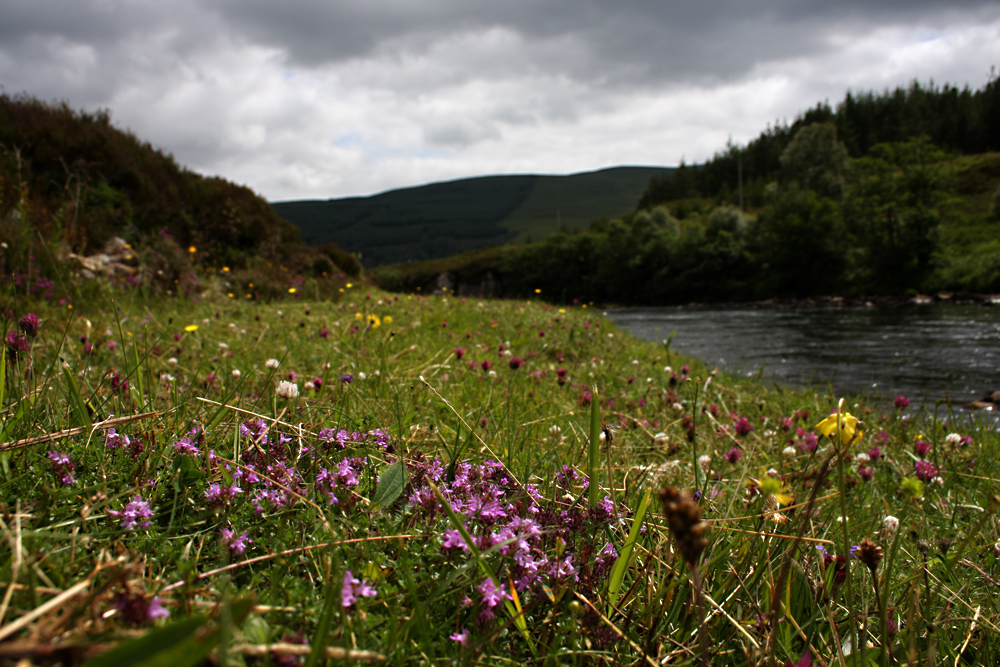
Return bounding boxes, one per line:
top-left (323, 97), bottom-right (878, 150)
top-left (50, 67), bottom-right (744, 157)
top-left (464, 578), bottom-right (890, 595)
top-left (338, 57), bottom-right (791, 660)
top-left (216, 0), bottom-right (996, 85)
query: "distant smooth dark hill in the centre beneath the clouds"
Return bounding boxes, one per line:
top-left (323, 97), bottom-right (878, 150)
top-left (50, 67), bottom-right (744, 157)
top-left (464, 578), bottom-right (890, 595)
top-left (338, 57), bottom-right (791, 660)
top-left (271, 167), bottom-right (672, 266)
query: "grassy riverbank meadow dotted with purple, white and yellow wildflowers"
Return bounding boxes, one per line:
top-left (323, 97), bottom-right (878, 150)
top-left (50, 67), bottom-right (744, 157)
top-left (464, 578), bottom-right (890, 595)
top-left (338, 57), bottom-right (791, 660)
top-left (0, 286), bottom-right (1000, 665)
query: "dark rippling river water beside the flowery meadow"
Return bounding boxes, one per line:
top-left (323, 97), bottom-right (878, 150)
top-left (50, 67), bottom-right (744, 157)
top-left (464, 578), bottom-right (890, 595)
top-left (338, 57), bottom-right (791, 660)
top-left (607, 304), bottom-right (1000, 404)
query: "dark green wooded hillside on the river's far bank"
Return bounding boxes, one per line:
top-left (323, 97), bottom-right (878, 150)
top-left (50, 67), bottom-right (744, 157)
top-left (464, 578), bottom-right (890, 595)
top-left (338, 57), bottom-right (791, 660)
top-left (375, 77), bottom-right (1000, 304)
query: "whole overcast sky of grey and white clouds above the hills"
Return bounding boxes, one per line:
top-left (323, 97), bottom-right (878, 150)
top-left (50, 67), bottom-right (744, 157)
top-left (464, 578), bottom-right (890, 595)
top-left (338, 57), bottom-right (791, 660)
top-left (0, 0), bottom-right (1000, 200)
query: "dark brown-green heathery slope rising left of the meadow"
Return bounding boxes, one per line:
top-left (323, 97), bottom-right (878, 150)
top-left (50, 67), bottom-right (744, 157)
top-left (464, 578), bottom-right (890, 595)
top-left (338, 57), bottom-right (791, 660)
top-left (0, 94), bottom-right (360, 298)
